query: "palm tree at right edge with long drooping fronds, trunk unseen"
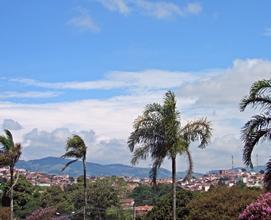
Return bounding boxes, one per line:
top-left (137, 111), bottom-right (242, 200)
top-left (240, 79), bottom-right (271, 191)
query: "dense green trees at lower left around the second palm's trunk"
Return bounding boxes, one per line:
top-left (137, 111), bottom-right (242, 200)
top-left (0, 177), bottom-right (125, 219)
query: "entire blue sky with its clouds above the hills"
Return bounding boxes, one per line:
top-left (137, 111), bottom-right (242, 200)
top-left (0, 0), bottom-right (271, 170)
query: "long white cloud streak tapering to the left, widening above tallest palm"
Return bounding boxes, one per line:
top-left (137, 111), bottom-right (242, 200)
top-left (9, 70), bottom-right (198, 90)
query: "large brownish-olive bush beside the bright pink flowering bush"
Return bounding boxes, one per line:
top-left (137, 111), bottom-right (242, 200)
top-left (185, 186), bottom-right (261, 220)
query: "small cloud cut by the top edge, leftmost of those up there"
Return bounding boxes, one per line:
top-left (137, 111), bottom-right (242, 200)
top-left (97, 0), bottom-right (130, 14)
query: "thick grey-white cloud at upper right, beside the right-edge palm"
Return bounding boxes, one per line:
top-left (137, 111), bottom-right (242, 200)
top-left (177, 59), bottom-right (271, 108)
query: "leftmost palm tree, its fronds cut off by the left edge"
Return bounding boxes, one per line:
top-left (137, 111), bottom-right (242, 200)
top-left (0, 130), bottom-right (22, 220)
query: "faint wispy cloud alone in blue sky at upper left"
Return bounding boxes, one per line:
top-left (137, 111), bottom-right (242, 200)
top-left (66, 7), bottom-right (100, 32)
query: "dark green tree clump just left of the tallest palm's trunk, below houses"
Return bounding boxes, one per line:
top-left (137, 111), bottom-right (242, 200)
top-left (130, 184), bottom-right (172, 205)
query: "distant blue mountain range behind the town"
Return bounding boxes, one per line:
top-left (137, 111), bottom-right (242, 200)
top-left (16, 157), bottom-right (203, 178)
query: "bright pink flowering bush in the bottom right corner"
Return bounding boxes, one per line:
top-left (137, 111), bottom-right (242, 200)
top-left (239, 192), bottom-right (271, 220)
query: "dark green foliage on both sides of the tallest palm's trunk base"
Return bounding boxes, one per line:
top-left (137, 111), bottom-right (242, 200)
top-left (146, 189), bottom-right (196, 220)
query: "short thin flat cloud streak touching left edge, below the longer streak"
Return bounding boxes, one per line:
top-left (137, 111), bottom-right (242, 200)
top-left (0, 91), bottom-right (60, 99)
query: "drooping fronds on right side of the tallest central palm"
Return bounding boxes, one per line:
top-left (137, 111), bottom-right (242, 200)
top-left (180, 119), bottom-right (212, 148)
